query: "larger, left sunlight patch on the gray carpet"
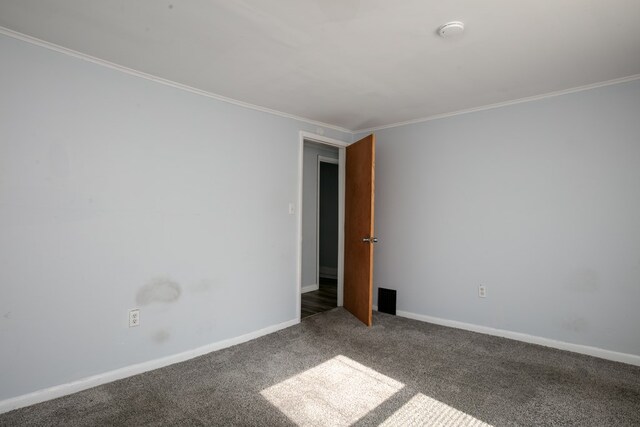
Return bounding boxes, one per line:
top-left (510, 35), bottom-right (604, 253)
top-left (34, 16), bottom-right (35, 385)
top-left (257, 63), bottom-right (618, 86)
top-left (261, 356), bottom-right (404, 426)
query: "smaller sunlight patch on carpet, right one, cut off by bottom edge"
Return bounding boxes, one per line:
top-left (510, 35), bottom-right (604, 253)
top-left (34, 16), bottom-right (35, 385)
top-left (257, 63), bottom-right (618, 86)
top-left (381, 393), bottom-right (491, 427)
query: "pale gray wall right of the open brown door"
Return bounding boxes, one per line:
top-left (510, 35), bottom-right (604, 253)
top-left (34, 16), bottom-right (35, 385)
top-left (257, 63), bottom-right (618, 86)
top-left (364, 80), bottom-right (640, 355)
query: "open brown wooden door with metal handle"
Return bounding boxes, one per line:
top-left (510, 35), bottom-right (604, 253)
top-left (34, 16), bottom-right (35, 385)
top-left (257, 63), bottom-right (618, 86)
top-left (344, 135), bottom-right (376, 326)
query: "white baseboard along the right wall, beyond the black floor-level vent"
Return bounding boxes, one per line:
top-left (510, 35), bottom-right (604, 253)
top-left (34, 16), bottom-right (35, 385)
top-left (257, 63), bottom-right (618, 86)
top-left (396, 311), bottom-right (640, 366)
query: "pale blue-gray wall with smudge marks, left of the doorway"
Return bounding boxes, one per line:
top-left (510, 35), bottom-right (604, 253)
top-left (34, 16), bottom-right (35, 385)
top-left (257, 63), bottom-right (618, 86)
top-left (0, 36), bottom-right (351, 400)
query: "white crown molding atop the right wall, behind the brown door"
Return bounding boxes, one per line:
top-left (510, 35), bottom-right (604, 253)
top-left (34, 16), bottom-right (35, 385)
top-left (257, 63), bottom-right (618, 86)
top-left (352, 74), bottom-right (640, 135)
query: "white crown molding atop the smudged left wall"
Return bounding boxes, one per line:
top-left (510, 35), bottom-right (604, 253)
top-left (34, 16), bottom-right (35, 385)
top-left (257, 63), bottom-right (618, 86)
top-left (0, 26), bottom-right (353, 134)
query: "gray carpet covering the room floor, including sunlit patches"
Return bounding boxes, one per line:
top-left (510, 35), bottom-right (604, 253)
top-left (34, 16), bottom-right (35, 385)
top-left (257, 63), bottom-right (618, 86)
top-left (0, 308), bottom-right (640, 426)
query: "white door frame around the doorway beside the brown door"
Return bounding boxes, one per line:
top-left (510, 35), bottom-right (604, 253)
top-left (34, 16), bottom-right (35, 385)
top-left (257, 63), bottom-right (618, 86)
top-left (295, 131), bottom-right (351, 322)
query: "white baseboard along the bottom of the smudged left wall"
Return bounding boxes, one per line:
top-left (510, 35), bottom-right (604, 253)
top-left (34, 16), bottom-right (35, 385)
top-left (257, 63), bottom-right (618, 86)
top-left (0, 319), bottom-right (300, 414)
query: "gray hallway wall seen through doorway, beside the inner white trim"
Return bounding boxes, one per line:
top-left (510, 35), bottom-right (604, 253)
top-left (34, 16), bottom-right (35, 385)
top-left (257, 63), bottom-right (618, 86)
top-left (302, 142), bottom-right (338, 287)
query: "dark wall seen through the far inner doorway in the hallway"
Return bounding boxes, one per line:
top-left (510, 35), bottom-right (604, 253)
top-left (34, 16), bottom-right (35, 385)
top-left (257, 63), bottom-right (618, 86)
top-left (318, 162), bottom-right (339, 273)
